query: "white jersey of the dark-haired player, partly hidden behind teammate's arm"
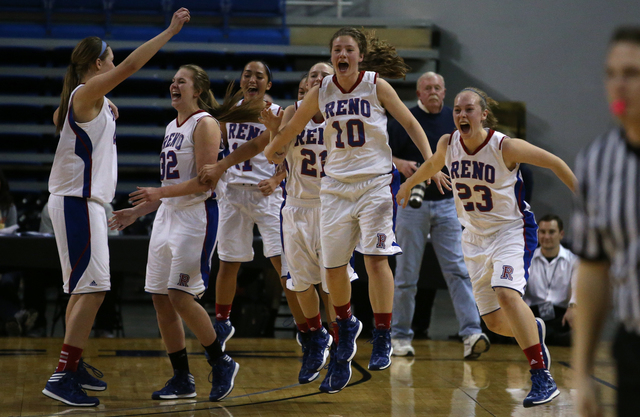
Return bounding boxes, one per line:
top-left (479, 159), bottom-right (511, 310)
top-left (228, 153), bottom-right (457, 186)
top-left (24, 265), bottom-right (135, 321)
top-left (226, 100), bottom-right (282, 185)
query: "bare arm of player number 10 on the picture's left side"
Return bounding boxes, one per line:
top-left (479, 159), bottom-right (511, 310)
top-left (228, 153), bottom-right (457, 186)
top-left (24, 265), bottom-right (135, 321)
top-left (264, 86), bottom-right (319, 163)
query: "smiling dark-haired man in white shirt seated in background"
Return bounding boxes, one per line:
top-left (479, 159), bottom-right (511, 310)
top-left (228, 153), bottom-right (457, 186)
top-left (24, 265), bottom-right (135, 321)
top-left (524, 214), bottom-right (578, 346)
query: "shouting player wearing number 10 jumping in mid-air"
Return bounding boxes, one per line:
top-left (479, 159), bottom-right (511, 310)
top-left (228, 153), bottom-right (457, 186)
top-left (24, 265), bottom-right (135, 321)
top-left (265, 28), bottom-right (440, 391)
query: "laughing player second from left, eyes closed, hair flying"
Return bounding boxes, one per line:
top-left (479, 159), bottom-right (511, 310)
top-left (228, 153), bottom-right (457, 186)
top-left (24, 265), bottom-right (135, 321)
top-left (110, 64), bottom-right (261, 401)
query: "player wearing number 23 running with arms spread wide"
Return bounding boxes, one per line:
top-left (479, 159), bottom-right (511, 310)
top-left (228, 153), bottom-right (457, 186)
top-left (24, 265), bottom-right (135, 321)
top-left (397, 88), bottom-right (576, 407)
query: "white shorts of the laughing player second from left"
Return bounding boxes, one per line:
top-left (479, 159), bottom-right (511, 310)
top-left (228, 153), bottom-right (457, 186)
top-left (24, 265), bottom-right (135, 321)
top-left (144, 198), bottom-right (218, 298)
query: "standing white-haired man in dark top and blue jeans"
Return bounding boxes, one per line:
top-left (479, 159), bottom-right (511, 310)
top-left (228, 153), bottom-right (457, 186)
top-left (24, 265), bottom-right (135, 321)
top-left (388, 72), bottom-right (490, 359)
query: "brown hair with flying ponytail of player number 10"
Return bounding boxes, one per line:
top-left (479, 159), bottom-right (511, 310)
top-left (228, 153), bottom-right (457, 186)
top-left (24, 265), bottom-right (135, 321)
top-left (329, 27), bottom-right (411, 78)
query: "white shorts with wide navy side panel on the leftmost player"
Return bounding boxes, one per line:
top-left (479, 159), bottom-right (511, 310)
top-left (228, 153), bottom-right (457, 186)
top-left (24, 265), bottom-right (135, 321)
top-left (47, 194), bottom-right (111, 294)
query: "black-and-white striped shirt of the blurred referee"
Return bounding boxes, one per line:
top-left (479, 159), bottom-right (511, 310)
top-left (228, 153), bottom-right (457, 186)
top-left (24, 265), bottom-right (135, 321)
top-left (572, 128), bottom-right (640, 335)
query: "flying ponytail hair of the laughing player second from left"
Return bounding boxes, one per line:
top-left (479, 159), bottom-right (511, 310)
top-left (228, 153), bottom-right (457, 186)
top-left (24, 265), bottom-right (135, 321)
top-left (180, 64), bottom-right (264, 123)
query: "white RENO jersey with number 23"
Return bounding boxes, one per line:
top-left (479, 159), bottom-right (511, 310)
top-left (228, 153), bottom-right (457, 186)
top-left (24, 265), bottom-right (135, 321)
top-left (445, 129), bottom-right (533, 236)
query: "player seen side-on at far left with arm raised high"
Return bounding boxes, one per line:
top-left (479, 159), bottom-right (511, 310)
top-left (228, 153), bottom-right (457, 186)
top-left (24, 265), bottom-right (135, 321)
top-left (42, 8), bottom-right (190, 406)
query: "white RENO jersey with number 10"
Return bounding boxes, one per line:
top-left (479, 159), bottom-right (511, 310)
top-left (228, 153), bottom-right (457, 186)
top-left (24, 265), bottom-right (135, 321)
top-left (318, 71), bottom-right (393, 182)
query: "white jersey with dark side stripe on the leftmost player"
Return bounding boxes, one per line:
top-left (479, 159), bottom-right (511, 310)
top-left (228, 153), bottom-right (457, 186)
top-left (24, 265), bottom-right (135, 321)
top-left (49, 84), bottom-right (118, 203)
